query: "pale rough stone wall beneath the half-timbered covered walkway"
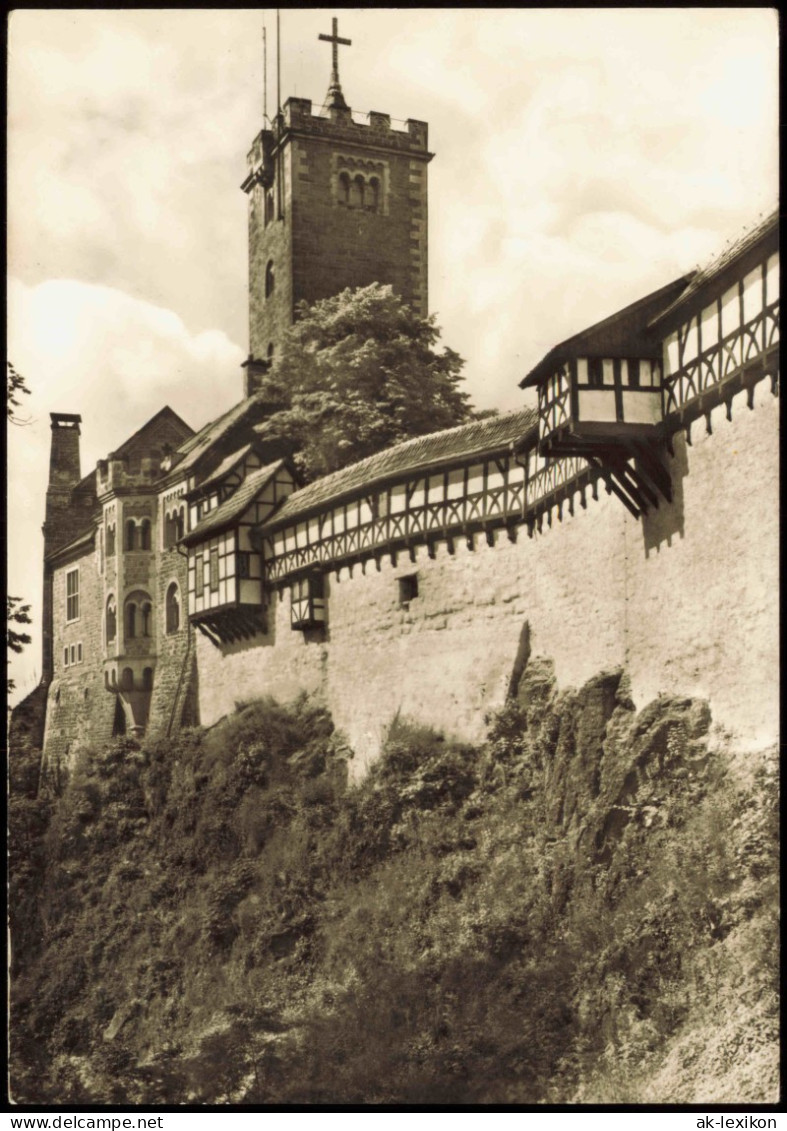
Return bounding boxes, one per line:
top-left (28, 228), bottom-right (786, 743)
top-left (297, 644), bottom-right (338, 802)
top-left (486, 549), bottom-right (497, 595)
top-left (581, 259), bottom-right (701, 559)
top-left (197, 382), bottom-right (779, 774)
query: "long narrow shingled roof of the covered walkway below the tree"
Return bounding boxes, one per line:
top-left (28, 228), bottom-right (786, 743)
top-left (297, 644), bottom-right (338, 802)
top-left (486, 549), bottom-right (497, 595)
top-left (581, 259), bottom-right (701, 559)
top-left (256, 408), bottom-right (537, 530)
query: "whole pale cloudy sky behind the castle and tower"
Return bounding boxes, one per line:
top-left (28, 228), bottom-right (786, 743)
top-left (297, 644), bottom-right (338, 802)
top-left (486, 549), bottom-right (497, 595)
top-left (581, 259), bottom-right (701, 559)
top-left (8, 8), bottom-right (778, 691)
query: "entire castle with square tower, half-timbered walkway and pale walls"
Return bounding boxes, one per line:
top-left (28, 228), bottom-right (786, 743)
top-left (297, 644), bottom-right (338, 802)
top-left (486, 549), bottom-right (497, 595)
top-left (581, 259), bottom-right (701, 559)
top-left (32, 50), bottom-right (779, 787)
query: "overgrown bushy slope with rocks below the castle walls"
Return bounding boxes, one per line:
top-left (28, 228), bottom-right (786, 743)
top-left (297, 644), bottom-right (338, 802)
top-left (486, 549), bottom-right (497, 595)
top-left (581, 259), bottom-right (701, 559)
top-left (11, 662), bottom-right (778, 1104)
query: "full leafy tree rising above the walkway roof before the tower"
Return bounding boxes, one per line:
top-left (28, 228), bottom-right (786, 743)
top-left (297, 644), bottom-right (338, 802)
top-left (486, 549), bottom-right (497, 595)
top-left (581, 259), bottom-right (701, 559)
top-left (259, 283), bottom-right (478, 480)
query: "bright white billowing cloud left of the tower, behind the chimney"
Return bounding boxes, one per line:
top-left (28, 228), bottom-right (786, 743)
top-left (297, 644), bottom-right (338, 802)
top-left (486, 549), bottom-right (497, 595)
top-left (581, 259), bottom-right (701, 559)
top-left (8, 279), bottom-right (245, 689)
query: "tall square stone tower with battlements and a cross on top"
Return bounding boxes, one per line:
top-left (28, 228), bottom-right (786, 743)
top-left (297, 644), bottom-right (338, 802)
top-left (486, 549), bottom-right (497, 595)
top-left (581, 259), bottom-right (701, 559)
top-left (242, 20), bottom-right (432, 396)
